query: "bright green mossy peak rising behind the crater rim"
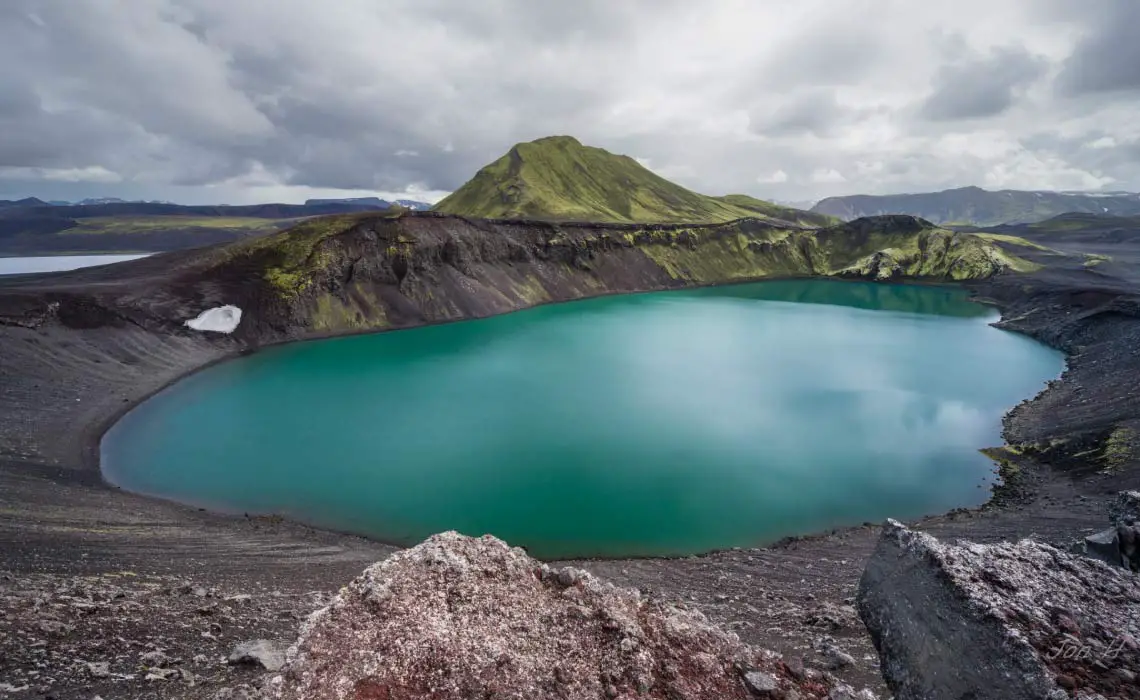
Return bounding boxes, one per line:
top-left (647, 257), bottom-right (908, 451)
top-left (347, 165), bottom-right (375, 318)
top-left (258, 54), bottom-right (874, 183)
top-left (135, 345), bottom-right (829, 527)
top-left (434, 136), bottom-right (833, 226)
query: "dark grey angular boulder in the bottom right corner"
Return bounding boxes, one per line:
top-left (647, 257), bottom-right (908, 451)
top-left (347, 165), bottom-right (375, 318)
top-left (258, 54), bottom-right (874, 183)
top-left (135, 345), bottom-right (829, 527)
top-left (857, 521), bottom-right (1140, 700)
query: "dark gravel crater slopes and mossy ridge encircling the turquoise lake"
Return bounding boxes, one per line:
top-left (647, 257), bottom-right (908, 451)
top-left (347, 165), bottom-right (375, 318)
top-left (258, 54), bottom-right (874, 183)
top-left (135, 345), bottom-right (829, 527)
top-left (0, 214), bottom-right (1140, 698)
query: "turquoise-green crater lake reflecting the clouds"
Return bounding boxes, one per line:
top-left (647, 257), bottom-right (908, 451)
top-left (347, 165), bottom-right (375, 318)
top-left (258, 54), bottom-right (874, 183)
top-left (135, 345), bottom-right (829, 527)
top-left (103, 280), bottom-right (1062, 557)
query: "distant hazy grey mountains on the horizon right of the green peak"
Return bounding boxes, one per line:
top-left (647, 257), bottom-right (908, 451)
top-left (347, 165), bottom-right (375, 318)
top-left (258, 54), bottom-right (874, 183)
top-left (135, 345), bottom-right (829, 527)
top-left (812, 187), bottom-right (1140, 226)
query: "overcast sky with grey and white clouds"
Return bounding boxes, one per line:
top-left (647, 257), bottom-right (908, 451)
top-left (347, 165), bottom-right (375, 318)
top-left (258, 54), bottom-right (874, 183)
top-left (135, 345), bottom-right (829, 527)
top-left (0, 0), bottom-right (1140, 203)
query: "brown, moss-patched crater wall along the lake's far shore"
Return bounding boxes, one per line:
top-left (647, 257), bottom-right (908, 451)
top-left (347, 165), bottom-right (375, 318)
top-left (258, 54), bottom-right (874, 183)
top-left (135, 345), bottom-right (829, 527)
top-left (200, 212), bottom-right (1033, 342)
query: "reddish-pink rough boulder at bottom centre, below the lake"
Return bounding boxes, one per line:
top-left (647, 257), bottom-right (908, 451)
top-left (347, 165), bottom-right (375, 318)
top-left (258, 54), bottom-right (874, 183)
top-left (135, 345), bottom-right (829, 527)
top-left (269, 532), bottom-right (839, 700)
